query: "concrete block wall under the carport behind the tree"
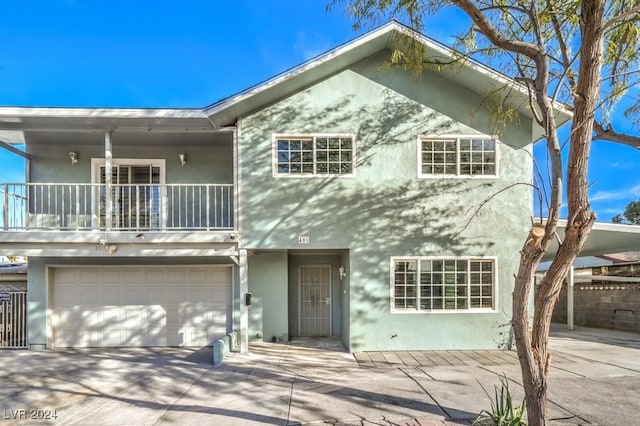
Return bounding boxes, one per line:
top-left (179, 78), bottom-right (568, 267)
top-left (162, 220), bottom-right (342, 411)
top-left (552, 283), bottom-right (640, 332)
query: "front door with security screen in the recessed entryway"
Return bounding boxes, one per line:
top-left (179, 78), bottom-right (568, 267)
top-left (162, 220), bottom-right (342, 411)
top-left (298, 265), bottom-right (331, 336)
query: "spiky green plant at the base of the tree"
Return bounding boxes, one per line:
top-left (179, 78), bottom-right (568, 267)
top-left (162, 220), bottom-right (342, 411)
top-left (473, 374), bottom-right (527, 426)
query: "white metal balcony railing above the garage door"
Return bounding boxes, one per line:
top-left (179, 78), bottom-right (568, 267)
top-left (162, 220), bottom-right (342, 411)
top-left (0, 183), bottom-right (235, 231)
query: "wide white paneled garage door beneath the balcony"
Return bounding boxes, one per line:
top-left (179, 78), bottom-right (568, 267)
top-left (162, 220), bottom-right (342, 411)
top-left (51, 266), bottom-right (231, 347)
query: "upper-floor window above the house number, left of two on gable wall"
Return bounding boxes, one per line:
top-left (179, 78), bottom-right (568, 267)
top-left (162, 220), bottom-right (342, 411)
top-left (275, 135), bottom-right (354, 176)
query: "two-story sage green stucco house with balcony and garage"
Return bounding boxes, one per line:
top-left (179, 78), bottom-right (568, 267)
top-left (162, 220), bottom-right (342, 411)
top-left (0, 22), bottom-right (568, 351)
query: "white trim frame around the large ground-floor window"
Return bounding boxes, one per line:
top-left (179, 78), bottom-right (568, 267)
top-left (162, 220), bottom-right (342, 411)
top-left (389, 256), bottom-right (500, 315)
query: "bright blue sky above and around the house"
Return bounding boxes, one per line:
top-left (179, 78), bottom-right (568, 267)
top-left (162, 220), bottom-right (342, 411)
top-left (0, 0), bottom-right (640, 221)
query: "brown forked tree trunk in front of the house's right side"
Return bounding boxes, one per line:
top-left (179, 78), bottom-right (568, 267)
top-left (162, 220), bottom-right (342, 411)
top-left (513, 0), bottom-right (605, 426)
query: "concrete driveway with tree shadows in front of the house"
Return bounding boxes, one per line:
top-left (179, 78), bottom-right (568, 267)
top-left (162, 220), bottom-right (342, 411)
top-left (0, 329), bottom-right (640, 426)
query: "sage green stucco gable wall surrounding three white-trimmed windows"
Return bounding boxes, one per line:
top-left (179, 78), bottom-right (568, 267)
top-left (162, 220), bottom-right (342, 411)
top-left (240, 51), bottom-right (532, 350)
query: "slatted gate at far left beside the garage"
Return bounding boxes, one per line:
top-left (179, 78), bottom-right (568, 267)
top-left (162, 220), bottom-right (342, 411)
top-left (0, 286), bottom-right (27, 348)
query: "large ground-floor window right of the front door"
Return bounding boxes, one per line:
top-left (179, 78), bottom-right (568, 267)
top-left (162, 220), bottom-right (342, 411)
top-left (391, 258), bottom-right (496, 311)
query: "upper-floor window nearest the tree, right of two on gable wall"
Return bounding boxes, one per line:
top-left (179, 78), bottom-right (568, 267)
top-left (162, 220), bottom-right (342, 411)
top-left (419, 136), bottom-right (497, 176)
